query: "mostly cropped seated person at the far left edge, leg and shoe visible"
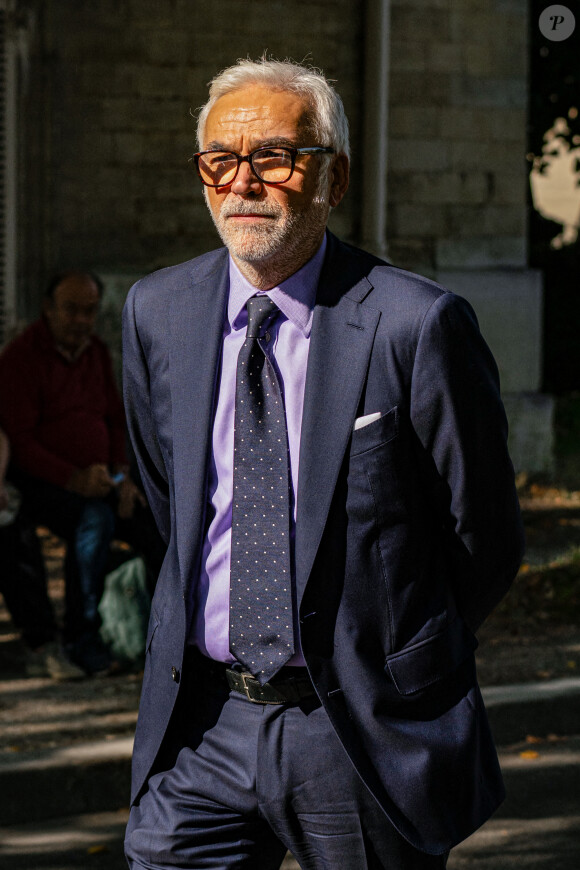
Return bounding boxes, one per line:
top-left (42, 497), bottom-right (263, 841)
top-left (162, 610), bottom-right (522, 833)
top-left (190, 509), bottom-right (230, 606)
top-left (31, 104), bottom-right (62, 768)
top-left (0, 429), bottom-right (84, 680)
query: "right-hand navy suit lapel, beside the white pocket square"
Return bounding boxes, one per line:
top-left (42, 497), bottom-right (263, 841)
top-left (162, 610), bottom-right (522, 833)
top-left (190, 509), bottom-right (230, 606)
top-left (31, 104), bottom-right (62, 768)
top-left (296, 237), bottom-right (380, 602)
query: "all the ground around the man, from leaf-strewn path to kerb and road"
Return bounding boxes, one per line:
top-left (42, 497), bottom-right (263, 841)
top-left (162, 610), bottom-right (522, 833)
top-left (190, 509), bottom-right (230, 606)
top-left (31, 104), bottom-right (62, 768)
top-left (0, 503), bottom-right (580, 870)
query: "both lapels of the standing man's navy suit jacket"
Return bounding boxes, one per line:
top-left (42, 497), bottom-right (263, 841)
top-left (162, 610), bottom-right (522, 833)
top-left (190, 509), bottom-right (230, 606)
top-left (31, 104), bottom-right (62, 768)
top-left (164, 236), bottom-right (380, 601)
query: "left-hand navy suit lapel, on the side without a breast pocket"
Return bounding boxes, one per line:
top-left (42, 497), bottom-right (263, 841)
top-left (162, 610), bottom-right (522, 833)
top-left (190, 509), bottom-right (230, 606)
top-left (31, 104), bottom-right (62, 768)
top-left (169, 251), bottom-right (228, 587)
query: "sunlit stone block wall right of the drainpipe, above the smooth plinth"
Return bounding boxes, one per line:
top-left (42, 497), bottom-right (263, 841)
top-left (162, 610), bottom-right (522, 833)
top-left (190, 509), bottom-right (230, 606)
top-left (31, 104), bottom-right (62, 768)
top-left (388, 0), bottom-right (528, 275)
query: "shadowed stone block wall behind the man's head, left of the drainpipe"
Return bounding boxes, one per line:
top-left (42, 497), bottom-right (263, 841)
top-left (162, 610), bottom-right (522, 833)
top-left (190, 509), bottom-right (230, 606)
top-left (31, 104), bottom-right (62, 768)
top-left (38, 0), bottom-right (362, 284)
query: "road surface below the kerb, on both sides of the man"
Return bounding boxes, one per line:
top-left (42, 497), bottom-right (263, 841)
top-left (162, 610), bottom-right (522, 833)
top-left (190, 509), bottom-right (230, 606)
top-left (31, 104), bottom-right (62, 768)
top-left (0, 737), bottom-right (580, 870)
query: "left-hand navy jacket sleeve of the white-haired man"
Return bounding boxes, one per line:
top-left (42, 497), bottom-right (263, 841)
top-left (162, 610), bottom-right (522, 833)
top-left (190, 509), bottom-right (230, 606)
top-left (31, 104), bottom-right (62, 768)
top-left (123, 283), bottom-right (171, 544)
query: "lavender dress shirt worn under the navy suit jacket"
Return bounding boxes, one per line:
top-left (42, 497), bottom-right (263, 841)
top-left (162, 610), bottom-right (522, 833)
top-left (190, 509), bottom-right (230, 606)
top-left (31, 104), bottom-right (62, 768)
top-left (189, 237), bottom-right (326, 665)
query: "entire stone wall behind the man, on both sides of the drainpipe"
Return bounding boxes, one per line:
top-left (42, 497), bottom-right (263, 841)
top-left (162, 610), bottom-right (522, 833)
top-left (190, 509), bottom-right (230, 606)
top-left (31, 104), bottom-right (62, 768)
top-left (13, 0), bottom-right (550, 470)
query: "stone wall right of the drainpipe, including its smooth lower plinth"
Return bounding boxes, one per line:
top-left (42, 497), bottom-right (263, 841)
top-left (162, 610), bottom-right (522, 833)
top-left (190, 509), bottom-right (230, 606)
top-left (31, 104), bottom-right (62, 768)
top-left (388, 0), bottom-right (554, 472)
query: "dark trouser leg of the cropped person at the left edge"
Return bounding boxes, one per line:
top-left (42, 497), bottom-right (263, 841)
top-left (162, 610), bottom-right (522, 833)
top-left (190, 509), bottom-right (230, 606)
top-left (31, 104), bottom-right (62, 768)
top-left (0, 516), bottom-right (56, 649)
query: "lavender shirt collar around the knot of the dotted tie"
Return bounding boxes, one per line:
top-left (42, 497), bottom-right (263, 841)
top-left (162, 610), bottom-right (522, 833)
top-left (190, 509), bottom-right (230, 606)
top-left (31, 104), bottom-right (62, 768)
top-left (227, 234), bottom-right (326, 338)
